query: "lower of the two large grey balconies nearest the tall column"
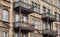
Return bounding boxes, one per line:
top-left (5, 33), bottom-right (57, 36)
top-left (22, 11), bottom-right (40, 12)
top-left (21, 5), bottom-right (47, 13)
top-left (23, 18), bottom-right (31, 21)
top-left (14, 21), bottom-right (34, 31)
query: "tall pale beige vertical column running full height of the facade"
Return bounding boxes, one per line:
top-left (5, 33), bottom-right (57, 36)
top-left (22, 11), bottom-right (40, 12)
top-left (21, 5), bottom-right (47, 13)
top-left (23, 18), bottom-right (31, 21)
top-left (9, 0), bottom-right (13, 37)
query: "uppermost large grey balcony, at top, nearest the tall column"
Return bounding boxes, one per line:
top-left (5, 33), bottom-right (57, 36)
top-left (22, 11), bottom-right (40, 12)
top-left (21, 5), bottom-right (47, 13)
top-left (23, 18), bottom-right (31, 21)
top-left (14, 1), bottom-right (34, 13)
